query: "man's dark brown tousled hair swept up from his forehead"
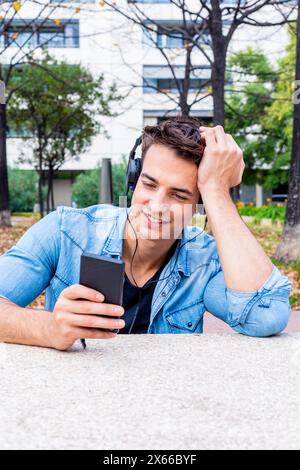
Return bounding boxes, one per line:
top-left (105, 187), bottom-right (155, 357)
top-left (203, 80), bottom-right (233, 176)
top-left (142, 116), bottom-right (205, 166)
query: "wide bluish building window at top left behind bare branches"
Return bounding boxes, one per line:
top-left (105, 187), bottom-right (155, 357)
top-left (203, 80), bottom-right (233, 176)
top-left (0, 20), bottom-right (79, 48)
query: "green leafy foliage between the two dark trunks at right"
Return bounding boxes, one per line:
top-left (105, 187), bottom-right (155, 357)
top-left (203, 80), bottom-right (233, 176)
top-left (226, 26), bottom-right (296, 189)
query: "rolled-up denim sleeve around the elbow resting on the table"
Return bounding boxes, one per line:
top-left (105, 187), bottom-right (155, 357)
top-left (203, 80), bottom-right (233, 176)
top-left (204, 260), bottom-right (292, 336)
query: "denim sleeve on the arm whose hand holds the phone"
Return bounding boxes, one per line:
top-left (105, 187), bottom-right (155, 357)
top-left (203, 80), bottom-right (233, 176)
top-left (0, 210), bottom-right (60, 307)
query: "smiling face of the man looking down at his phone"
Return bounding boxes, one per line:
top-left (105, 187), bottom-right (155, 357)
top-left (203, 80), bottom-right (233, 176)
top-left (131, 144), bottom-right (199, 239)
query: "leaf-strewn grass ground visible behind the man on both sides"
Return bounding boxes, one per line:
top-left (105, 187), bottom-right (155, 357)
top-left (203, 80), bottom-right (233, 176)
top-left (0, 214), bottom-right (300, 310)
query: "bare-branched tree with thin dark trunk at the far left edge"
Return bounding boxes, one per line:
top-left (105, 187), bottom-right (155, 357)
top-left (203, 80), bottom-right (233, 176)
top-left (0, 0), bottom-right (80, 226)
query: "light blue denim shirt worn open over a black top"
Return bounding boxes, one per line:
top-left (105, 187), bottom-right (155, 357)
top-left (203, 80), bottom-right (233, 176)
top-left (0, 204), bottom-right (291, 336)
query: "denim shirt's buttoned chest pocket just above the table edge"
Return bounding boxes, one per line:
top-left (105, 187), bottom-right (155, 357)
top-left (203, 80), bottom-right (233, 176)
top-left (165, 301), bottom-right (205, 333)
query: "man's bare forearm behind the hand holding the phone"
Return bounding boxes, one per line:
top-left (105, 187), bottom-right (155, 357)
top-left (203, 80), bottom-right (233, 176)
top-left (0, 299), bottom-right (53, 347)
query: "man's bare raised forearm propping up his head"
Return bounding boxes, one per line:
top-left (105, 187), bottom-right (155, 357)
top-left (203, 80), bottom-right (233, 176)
top-left (201, 189), bottom-right (273, 292)
